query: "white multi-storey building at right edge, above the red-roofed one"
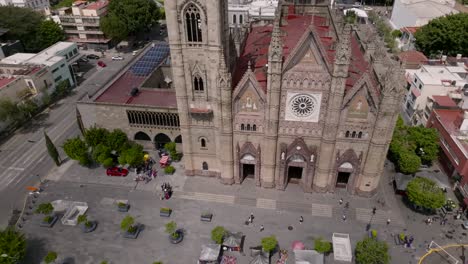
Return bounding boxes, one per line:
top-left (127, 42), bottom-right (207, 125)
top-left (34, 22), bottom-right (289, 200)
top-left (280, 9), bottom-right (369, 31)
top-left (403, 62), bottom-right (468, 125)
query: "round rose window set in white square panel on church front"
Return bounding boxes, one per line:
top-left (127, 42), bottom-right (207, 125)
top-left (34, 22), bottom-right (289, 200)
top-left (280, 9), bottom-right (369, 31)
top-left (285, 93), bottom-right (322, 122)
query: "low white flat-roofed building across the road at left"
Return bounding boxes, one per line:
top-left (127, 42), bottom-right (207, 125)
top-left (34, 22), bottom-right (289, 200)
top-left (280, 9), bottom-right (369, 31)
top-left (0, 42), bottom-right (80, 87)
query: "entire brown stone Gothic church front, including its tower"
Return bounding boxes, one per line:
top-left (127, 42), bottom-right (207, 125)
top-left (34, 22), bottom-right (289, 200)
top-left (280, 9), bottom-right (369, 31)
top-left (165, 0), bottom-right (404, 196)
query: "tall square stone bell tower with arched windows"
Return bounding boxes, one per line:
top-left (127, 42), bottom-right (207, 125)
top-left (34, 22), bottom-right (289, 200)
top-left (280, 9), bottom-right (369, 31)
top-left (164, 0), bottom-right (234, 184)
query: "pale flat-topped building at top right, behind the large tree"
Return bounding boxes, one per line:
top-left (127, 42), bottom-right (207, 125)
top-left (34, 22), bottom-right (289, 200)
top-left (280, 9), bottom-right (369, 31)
top-left (390, 0), bottom-right (458, 29)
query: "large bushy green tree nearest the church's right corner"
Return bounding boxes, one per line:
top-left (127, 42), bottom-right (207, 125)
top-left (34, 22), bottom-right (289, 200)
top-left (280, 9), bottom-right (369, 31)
top-left (388, 117), bottom-right (439, 174)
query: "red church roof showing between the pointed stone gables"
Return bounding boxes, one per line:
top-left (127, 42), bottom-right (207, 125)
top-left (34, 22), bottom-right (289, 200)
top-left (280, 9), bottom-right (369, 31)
top-left (233, 12), bottom-right (374, 95)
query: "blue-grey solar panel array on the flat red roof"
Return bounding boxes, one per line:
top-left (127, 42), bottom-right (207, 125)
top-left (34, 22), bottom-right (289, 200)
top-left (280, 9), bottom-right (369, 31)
top-left (130, 42), bottom-right (169, 76)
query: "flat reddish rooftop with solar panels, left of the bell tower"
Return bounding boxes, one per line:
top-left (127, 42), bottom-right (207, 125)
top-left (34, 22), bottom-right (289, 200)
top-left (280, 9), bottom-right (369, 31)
top-left (94, 42), bottom-right (177, 109)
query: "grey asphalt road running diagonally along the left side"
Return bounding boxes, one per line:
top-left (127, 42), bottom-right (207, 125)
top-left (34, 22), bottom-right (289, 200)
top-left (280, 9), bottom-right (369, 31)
top-left (0, 54), bottom-right (133, 227)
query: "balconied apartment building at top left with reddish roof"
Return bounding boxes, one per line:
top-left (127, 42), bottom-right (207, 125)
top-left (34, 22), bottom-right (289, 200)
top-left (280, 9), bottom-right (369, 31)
top-left (53, 0), bottom-right (111, 49)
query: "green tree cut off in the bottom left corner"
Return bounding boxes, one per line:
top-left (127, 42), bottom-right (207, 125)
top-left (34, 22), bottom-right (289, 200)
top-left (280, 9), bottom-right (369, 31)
top-left (0, 228), bottom-right (26, 264)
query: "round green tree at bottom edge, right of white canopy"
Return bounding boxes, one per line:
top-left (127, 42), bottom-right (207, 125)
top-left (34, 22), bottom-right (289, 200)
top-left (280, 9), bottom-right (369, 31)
top-left (356, 238), bottom-right (390, 264)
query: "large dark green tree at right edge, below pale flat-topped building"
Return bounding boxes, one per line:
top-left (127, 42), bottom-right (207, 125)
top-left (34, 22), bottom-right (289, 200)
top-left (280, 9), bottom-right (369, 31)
top-left (414, 13), bottom-right (468, 57)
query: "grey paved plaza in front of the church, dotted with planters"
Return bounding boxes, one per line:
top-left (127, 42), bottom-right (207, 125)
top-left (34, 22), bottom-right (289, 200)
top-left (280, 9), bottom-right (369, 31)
top-left (13, 156), bottom-right (466, 264)
